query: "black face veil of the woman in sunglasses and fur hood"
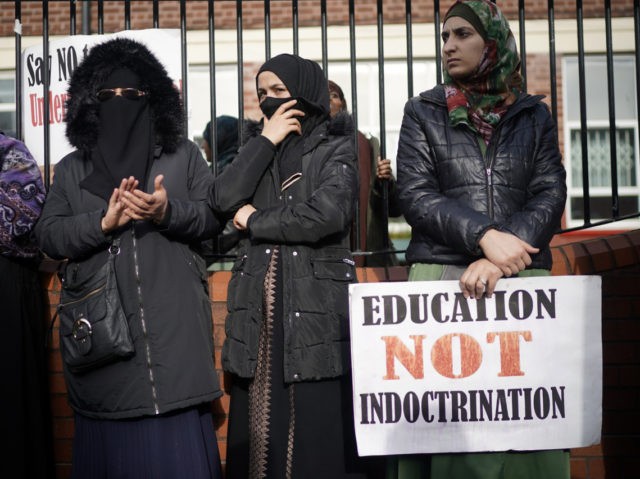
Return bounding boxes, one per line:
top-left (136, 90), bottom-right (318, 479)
top-left (81, 68), bottom-right (154, 201)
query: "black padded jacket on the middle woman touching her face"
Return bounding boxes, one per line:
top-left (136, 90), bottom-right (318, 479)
top-left (212, 112), bottom-right (358, 382)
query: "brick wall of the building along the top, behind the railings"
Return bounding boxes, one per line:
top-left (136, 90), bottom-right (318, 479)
top-left (0, 0), bottom-right (633, 36)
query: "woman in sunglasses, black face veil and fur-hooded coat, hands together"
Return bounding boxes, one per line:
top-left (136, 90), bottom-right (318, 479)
top-left (36, 38), bottom-right (222, 479)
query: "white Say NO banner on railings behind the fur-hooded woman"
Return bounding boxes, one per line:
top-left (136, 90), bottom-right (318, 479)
top-left (22, 29), bottom-right (182, 165)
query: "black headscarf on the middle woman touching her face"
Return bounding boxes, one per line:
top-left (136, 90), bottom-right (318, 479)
top-left (256, 53), bottom-right (329, 181)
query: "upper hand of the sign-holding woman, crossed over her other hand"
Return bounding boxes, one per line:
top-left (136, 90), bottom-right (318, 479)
top-left (479, 229), bottom-right (540, 277)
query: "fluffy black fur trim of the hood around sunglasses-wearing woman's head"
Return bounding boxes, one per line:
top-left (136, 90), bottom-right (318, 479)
top-left (66, 38), bottom-right (184, 152)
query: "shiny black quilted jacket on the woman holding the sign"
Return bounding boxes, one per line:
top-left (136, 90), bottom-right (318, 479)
top-left (397, 86), bottom-right (566, 269)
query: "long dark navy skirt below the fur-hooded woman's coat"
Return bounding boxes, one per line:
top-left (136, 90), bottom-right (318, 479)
top-left (71, 404), bottom-right (222, 479)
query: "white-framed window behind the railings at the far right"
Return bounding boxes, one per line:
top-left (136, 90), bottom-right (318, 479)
top-left (564, 55), bottom-right (640, 228)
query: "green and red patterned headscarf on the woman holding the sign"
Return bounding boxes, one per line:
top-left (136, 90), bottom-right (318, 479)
top-left (443, 0), bottom-right (522, 144)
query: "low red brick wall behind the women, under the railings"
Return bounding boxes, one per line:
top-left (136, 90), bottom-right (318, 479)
top-left (44, 230), bottom-right (640, 479)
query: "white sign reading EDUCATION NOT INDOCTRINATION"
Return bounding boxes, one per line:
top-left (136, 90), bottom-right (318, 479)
top-left (349, 276), bottom-right (602, 456)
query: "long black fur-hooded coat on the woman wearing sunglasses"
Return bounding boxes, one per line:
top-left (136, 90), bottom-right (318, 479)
top-left (36, 39), bottom-right (222, 419)
